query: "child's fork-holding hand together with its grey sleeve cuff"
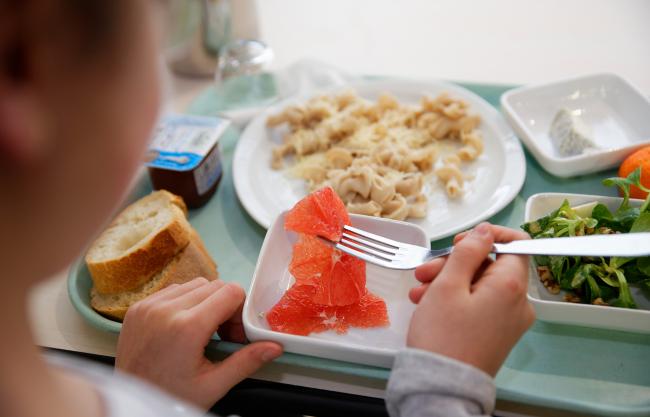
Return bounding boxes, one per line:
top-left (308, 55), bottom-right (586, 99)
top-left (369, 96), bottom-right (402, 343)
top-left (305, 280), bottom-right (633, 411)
top-left (386, 224), bottom-right (535, 417)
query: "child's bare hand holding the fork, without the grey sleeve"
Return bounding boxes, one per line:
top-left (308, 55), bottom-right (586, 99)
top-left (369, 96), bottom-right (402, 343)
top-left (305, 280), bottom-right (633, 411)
top-left (407, 223), bottom-right (535, 376)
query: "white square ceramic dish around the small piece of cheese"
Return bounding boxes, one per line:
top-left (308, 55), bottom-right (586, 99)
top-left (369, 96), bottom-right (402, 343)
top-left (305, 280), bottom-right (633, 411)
top-left (501, 74), bottom-right (650, 177)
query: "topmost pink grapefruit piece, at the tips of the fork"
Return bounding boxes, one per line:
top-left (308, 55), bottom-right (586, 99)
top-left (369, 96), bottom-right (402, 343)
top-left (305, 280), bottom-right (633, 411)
top-left (284, 187), bottom-right (350, 241)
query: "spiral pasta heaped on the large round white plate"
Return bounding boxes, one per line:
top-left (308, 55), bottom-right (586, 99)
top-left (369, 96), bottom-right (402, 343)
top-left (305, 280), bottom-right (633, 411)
top-left (267, 91), bottom-right (483, 220)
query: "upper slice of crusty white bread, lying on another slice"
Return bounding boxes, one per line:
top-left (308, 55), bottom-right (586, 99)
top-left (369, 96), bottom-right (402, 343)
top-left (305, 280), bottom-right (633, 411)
top-left (85, 190), bottom-right (190, 294)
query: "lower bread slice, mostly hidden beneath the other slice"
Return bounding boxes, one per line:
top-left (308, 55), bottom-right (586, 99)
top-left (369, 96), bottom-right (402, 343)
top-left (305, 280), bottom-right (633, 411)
top-left (90, 235), bottom-right (218, 320)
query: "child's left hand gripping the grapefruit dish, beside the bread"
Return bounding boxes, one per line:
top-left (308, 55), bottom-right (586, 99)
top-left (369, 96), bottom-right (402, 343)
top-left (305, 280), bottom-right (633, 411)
top-left (116, 278), bottom-right (282, 409)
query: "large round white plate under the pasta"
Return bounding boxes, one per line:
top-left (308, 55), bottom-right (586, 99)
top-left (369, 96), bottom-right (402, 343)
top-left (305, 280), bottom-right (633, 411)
top-left (233, 81), bottom-right (526, 240)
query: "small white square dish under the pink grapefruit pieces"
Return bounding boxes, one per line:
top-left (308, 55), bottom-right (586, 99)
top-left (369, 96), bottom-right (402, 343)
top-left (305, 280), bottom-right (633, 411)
top-left (243, 213), bottom-right (429, 367)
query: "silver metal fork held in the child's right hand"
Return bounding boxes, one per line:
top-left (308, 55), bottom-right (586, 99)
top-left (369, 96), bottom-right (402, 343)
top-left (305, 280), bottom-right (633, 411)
top-left (321, 226), bottom-right (650, 269)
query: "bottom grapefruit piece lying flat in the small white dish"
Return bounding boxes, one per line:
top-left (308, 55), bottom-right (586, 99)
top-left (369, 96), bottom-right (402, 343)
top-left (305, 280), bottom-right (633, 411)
top-left (266, 284), bottom-right (389, 336)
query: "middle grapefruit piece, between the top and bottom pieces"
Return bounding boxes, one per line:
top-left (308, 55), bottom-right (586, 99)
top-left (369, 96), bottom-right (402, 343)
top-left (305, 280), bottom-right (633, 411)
top-left (289, 235), bottom-right (366, 306)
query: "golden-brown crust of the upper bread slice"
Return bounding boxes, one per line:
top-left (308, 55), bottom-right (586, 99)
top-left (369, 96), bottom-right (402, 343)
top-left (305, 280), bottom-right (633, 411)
top-left (85, 191), bottom-right (190, 294)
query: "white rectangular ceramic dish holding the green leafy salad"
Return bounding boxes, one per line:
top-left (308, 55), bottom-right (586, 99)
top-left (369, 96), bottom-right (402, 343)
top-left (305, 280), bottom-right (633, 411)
top-left (525, 193), bottom-right (650, 333)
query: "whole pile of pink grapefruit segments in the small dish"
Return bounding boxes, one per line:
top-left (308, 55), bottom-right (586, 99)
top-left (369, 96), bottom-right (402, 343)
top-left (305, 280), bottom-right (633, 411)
top-left (266, 187), bottom-right (389, 335)
